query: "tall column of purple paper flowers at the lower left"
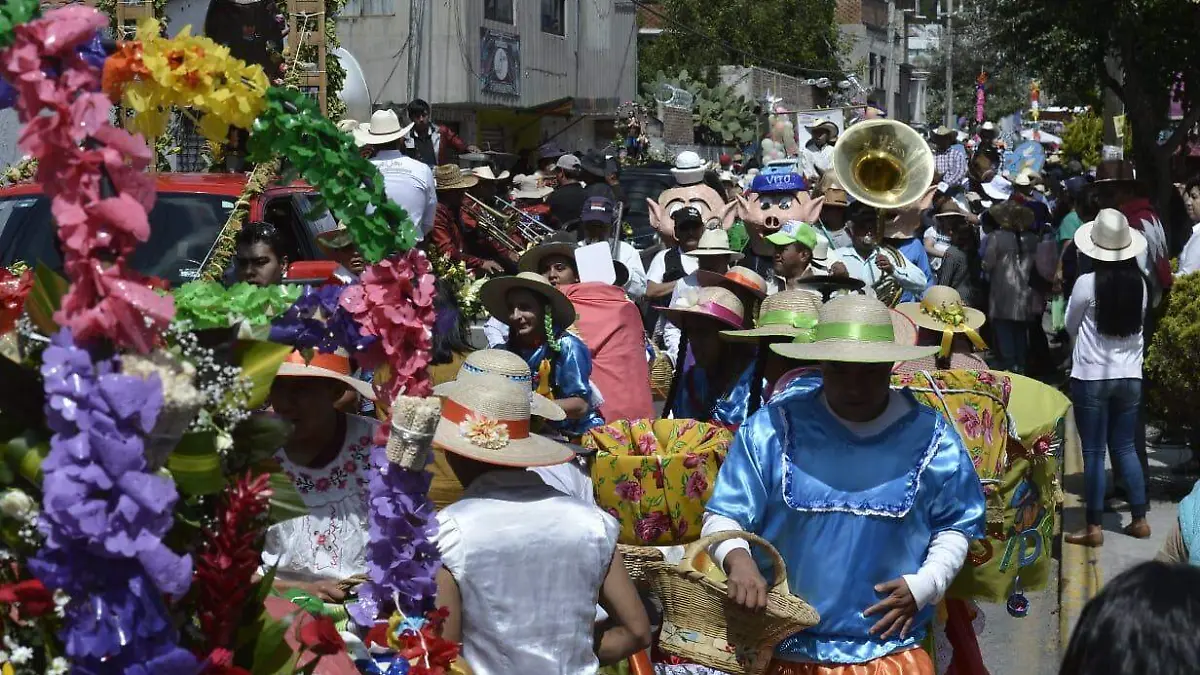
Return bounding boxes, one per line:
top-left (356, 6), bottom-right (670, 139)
top-left (29, 329), bottom-right (198, 675)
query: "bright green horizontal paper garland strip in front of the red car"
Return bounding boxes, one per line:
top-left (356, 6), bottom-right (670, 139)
top-left (172, 281), bottom-right (300, 330)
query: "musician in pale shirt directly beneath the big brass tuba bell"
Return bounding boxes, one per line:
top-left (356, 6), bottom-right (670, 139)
top-left (830, 202), bottom-right (928, 305)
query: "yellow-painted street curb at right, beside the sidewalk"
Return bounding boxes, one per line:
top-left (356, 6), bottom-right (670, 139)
top-left (1058, 410), bottom-right (1103, 652)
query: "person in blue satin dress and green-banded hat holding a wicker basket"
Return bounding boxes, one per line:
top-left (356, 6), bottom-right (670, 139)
top-left (704, 295), bottom-right (985, 675)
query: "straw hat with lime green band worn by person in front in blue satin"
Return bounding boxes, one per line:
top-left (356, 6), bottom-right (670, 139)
top-left (770, 295), bottom-right (937, 363)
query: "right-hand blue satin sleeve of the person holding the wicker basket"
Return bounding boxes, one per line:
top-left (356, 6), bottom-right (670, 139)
top-left (928, 424), bottom-right (988, 539)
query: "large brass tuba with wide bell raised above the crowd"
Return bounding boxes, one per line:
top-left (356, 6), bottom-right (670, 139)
top-left (833, 120), bottom-right (935, 307)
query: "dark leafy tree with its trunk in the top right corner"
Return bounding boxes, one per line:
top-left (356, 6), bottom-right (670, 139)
top-left (978, 0), bottom-right (1200, 209)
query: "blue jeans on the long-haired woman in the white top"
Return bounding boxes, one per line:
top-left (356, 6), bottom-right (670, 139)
top-left (1070, 378), bottom-right (1146, 525)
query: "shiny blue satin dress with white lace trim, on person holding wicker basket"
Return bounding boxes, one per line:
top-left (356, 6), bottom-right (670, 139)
top-left (707, 388), bottom-right (985, 664)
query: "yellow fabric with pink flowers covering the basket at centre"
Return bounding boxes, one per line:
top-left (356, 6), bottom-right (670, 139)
top-left (583, 419), bottom-right (733, 546)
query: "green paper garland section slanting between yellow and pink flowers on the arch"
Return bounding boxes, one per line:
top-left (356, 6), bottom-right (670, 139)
top-left (250, 86), bottom-right (416, 264)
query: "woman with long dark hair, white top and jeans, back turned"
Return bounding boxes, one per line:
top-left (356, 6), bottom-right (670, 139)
top-left (1066, 209), bottom-right (1150, 546)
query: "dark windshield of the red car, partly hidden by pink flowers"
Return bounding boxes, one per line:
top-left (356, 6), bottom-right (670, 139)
top-left (0, 192), bottom-right (234, 286)
